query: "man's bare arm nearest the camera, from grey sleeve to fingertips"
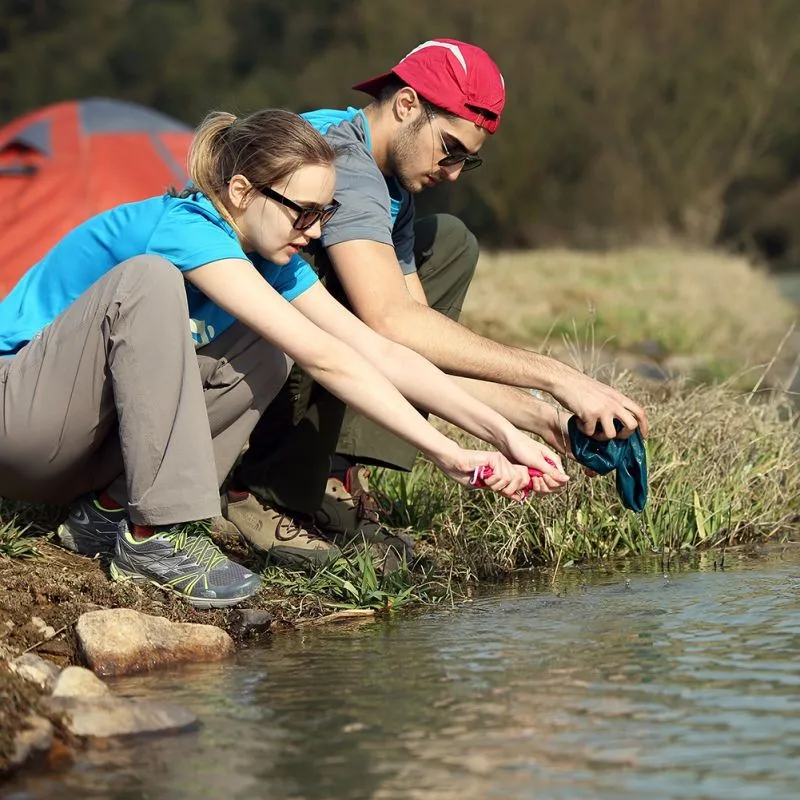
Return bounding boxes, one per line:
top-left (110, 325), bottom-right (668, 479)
top-left (327, 240), bottom-right (647, 438)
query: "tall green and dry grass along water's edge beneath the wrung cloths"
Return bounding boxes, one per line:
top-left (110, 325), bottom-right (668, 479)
top-left (377, 376), bottom-right (800, 579)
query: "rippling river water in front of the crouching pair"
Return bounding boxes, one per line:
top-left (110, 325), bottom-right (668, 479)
top-left (3, 552), bottom-right (800, 800)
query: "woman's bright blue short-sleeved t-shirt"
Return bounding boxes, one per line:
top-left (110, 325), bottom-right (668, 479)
top-left (0, 193), bottom-right (317, 355)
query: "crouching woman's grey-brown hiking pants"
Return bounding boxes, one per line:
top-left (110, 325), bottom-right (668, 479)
top-left (0, 256), bottom-right (291, 525)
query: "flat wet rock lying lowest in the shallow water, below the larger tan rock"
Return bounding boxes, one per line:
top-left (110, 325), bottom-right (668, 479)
top-left (44, 696), bottom-right (197, 738)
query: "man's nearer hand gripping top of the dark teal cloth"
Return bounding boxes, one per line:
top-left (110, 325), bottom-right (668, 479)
top-left (551, 373), bottom-right (648, 439)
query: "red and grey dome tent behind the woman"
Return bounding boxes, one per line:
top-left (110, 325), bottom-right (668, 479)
top-left (0, 98), bottom-right (192, 297)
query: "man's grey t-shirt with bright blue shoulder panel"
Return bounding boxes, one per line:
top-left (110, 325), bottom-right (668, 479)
top-left (302, 108), bottom-right (417, 275)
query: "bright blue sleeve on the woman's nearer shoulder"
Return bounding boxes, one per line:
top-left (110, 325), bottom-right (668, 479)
top-left (147, 204), bottom-right (246, 272)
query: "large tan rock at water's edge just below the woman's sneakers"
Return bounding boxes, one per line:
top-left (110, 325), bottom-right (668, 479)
top-left (75, 608), bottom-right (234, 675)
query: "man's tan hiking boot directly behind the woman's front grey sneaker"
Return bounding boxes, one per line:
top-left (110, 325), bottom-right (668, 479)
top-left (225, 492), bottom-right (342, 567)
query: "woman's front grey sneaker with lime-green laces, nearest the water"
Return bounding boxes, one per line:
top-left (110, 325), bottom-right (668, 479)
top-left (110, 521), bottom-right (261, 608)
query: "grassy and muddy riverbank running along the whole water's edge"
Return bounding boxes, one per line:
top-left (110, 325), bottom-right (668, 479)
top-left (0, 247), bottom-right (800, 771)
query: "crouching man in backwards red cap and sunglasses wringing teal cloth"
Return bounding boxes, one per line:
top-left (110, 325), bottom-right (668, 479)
top-left (226, 39), bottom-right (647, 563)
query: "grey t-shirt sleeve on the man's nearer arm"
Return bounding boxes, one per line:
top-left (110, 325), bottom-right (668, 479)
top-left (322, 145), bottom-right (394, 247)
